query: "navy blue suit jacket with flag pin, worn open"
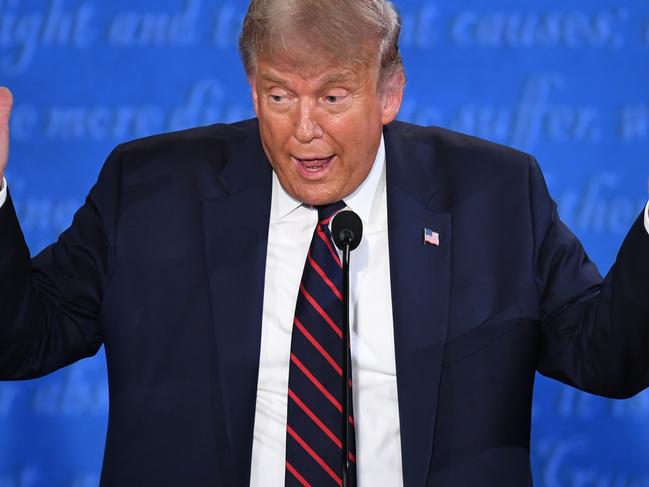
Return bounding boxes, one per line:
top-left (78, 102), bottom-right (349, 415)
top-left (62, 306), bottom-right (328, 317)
top-left (0, 120), bottom-right (649, 487)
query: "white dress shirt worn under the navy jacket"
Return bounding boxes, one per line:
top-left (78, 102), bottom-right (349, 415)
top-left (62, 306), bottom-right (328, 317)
top-left (250, 140), bottom-right (403, 487)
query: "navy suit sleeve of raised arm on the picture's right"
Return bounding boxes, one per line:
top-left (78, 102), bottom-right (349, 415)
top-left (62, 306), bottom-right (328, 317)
top-left (530, 156), bottom-right (649, 398)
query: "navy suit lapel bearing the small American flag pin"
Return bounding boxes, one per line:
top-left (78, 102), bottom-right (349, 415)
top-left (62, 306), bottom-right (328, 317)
top-left (385, 124), bottom-right (451, 487)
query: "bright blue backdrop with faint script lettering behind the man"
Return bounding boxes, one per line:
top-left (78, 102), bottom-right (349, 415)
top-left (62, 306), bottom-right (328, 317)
top-left (0, 0), bottom-right (649, 487)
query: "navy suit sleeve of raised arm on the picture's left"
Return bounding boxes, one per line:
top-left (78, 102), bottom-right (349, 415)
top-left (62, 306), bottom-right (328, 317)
top-left (0, 149), bottom-right (119, 379)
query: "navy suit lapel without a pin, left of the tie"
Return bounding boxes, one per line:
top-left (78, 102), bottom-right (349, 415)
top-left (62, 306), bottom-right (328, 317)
top-left (203, 123), bottom-right (272, 485)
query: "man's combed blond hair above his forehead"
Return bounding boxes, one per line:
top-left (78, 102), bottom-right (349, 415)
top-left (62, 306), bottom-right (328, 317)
top-left (239, 0), bottom-right (403, 83)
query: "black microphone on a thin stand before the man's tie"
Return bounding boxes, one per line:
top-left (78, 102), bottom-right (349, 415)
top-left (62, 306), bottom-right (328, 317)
top-left (331, 210), bottom-right (363, 487)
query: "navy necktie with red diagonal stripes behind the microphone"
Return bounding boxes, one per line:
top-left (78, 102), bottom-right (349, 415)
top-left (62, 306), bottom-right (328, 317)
top-left (285, 201), bottom-right (356, 487)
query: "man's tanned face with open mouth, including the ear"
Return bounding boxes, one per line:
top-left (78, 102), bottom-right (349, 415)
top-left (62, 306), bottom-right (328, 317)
top-left (249, 53), bottom-right (403, 205)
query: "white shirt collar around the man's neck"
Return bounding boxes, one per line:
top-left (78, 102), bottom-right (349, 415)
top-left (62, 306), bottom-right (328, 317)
top-left (271, 135), bottom-right (385, 223)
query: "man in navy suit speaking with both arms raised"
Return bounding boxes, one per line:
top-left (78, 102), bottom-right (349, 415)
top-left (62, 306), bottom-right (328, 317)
top-left (0, 0), bottom-right (649, 486)
